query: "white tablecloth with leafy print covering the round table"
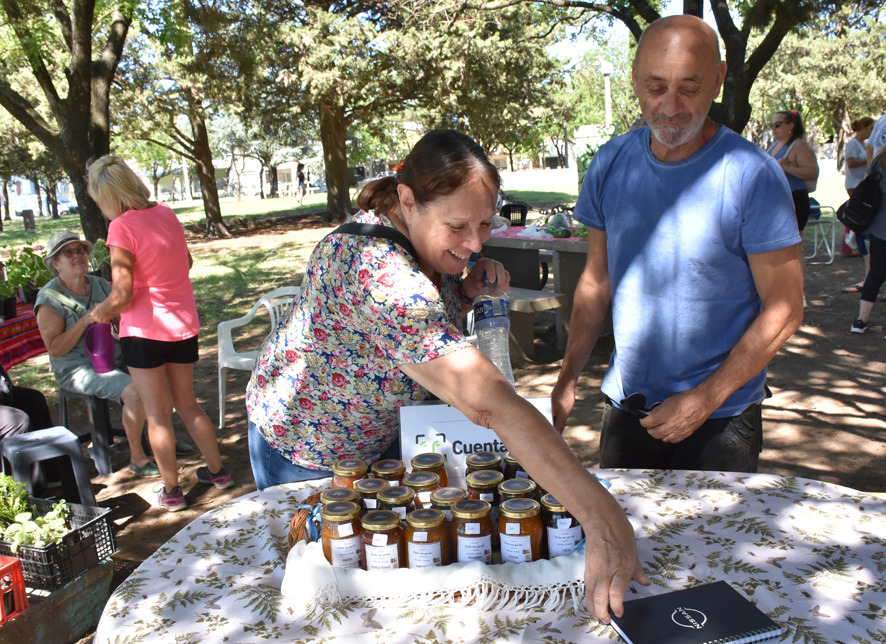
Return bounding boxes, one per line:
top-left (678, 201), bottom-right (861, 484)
top-left (95, 470), bottom-right (886, 644)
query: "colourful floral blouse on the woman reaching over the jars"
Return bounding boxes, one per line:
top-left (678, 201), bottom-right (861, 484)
top-left (246, 211), bottom-right (469, 469)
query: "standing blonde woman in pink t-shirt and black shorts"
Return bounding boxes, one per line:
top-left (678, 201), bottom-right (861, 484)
top-left (89, 156), bottom-right (234, 512)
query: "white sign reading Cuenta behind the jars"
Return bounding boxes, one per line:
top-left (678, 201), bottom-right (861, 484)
top-left (400, 398), bottom-right (552, 485)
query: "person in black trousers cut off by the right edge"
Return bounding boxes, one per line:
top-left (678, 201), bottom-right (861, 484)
top-left (849, 114), bottom-right (886, 333)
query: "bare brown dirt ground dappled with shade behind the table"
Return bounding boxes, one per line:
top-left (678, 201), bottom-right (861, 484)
top-left (71, 217), bottom-right (886, 641)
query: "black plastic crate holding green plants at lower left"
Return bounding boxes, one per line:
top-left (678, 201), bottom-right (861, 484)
top-left (0, 498), bottom-right (117, 590)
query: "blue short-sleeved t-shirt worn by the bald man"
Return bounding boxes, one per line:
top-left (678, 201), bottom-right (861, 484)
top-left (575, 127), bottom-right (800, 418)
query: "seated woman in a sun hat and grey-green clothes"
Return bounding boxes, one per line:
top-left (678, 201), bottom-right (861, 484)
top-left (34, 230), bottom-right (193, 476)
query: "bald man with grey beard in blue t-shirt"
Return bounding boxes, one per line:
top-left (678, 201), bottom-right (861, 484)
top-left (552, 16), bottom-right (803, 471)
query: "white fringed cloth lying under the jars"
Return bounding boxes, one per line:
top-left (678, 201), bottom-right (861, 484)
top-left (281, 542), bottom-right (585, 615)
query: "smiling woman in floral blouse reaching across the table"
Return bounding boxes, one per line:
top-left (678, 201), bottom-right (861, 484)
top-left (246, 130), bottom-right (649, 622)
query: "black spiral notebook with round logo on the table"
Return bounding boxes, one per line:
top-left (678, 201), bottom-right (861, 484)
top-left (610, 581), bottom-right (783, 644)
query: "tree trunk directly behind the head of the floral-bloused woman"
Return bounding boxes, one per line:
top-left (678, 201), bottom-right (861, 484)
top-left (319, 99), bottom-right (351, 223)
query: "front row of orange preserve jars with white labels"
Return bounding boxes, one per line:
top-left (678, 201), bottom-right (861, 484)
top-left (320, 490), bottom-right (583, 570)
